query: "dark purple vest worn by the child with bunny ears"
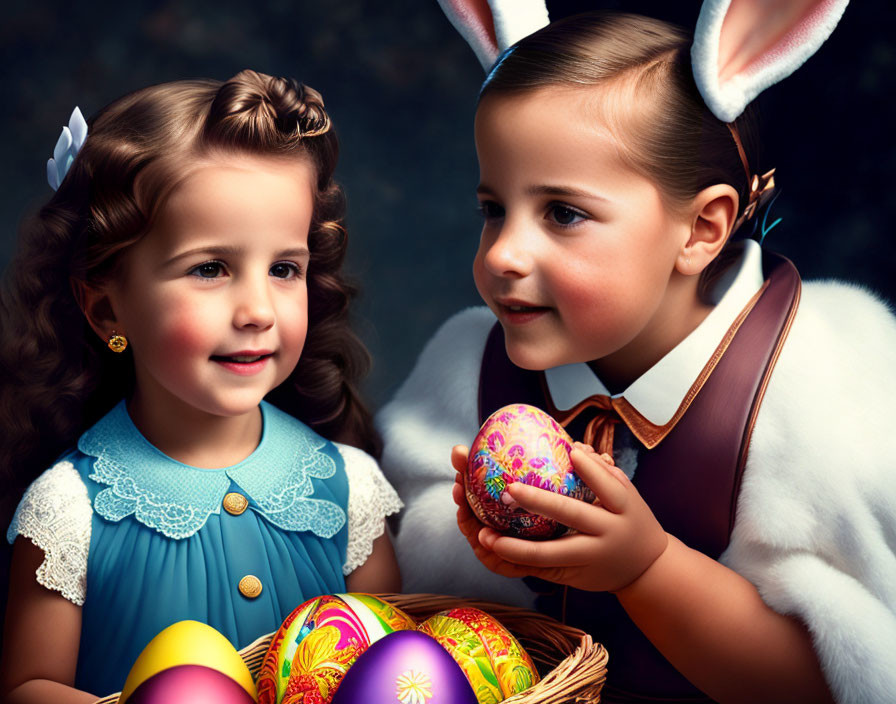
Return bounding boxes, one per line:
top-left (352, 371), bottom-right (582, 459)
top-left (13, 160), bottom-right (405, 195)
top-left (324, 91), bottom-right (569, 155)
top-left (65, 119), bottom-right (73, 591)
top-left (479, 253), bottom-right (800, 702)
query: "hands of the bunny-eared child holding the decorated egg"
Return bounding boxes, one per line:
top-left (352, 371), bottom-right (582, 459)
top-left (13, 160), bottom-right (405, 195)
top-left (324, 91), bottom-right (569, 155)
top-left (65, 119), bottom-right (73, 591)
top-left (452, 443), bottom-right (668, 591)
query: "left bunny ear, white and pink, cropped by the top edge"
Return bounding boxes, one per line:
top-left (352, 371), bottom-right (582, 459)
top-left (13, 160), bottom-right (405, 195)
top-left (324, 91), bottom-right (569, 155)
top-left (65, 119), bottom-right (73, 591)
top-left (439, 0), bottom-right (549, 71)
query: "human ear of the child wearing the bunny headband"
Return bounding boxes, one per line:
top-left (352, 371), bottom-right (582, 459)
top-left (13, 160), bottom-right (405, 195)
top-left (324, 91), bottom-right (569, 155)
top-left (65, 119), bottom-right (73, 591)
top-left (675, 184), bottom-right (739, 276)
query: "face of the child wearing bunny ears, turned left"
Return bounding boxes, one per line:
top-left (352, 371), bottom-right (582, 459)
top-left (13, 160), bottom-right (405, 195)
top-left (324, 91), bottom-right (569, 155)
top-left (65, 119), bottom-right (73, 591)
top-left (473, 87), bottom-right (696, 380)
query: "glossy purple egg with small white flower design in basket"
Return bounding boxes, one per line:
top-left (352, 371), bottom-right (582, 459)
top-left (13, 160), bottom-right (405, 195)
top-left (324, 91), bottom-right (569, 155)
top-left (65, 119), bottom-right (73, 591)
top-left (333, 631), bottom-right (477, 704)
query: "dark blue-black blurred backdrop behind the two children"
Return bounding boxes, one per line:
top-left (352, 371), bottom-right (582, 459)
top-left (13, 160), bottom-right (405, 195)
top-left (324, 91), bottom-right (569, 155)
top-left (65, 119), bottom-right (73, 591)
top-left (0, 0), bottom-right (896, 406)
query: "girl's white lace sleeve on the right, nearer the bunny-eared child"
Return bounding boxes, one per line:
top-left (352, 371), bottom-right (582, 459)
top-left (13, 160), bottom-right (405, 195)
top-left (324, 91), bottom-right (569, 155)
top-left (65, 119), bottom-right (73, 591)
top-left (336, 443), bottom-right (403, 575)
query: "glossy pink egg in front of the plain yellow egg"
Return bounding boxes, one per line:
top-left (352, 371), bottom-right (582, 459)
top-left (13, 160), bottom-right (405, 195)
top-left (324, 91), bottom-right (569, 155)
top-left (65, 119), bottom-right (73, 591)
top-left (128, 665), bottom-right (255, 704)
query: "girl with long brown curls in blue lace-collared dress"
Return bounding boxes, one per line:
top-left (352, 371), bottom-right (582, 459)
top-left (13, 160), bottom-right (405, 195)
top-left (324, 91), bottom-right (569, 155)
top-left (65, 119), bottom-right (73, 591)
top-left (0, 71), bottom-right (400, 702)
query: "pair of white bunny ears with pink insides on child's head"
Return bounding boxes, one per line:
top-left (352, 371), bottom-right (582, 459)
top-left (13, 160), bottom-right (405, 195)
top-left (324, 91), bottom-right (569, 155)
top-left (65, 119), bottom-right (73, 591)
top-left (439, 0), bottom-right (849, 122)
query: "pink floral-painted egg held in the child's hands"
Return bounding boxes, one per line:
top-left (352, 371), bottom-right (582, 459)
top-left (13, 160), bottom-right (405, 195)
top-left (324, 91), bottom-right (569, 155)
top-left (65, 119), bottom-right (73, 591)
top-left (465, 403), bottom-right (594, 539)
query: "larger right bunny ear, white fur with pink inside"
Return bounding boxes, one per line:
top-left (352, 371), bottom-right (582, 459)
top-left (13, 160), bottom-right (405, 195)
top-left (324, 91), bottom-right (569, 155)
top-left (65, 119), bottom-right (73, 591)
top-left (691, 0), bottom-right (848, 122)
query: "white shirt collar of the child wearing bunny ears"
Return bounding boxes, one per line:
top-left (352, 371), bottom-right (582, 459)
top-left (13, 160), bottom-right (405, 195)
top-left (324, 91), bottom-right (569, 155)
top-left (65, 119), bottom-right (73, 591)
top-left (545, 240), bottom-right (764, 426)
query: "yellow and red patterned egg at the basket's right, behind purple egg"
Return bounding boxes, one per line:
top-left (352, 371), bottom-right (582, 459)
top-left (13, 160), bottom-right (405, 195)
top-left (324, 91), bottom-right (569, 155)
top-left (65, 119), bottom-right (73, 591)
top-left (417, 607), bottom-right (539, 704)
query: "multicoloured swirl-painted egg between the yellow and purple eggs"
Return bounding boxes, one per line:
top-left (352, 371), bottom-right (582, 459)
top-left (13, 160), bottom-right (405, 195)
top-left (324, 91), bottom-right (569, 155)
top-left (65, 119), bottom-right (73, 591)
top-left (257, 594), bottom-right (417, 704)
